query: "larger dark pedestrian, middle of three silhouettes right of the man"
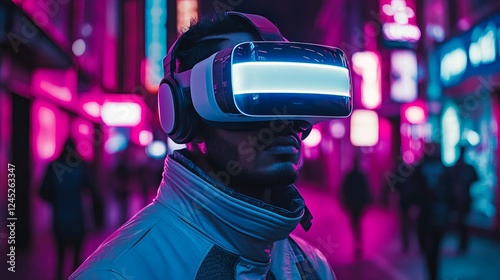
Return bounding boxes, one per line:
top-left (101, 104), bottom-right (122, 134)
top-left (411, 143), bottom-right (452, 280)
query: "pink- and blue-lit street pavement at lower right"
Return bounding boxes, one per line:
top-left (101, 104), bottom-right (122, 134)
top-left (294, 186), bottom-right (500, 280)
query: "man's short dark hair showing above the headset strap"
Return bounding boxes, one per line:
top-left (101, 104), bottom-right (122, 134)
top-left (174, 15), bottom-right (260, 72)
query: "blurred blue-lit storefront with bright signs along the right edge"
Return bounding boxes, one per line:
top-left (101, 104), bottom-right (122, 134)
top-left (428, 14), bottom-right (500, 232)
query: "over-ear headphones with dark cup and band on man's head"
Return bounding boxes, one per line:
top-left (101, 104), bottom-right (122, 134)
top-left (158, 11), bottom-right (287, 144)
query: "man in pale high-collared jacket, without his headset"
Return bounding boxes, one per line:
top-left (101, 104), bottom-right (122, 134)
top-left (71, 11), bottom-right (348, 279)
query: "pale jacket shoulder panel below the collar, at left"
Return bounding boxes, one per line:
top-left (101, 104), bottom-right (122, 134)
top-left (70, 204), bottom-right (212, 280)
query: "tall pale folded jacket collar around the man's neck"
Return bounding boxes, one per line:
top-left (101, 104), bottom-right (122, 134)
top-left (155, 152), bottom-right (310, 262)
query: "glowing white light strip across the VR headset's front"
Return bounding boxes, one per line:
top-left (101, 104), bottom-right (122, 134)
top-left (232, 62), bottom-right (350, 96)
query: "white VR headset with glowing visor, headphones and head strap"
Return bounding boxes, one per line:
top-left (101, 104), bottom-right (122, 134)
top-left (158, 12), bottom-right (352, 143)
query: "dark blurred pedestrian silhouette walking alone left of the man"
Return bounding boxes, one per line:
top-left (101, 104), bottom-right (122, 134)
top-left (39, 139), bottom-right (96, 279)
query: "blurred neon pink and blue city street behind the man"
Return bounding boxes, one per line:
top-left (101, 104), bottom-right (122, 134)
top-left (0, 0), bottom-right (500, 280)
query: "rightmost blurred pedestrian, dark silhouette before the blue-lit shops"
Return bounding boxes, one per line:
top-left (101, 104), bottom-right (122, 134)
top-left (448, 147), bottom-right (479, 253)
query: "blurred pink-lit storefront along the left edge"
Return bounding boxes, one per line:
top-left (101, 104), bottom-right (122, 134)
top-left (0, 1), bottom-right (108, 249)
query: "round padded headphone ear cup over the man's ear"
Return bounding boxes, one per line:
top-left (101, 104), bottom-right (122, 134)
top-left (158, 77), bottom-right (200, 144)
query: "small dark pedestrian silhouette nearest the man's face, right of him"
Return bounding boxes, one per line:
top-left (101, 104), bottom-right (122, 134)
top-left (341, 157), bottom-right (372, 257)
